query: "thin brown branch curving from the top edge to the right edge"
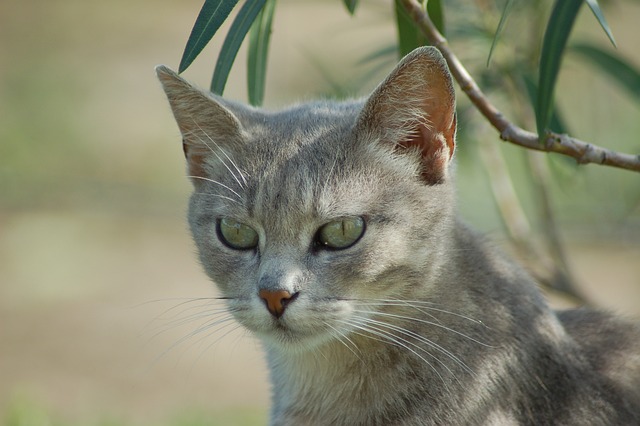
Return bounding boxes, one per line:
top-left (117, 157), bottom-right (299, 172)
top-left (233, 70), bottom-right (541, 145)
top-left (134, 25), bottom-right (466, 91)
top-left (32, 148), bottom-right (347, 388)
top-left (400, 0), bottom-right (640, 172)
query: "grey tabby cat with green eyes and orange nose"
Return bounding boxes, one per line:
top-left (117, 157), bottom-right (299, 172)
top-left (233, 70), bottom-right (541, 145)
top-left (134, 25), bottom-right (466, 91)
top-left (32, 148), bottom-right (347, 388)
top-left (156, 47), bottom-right (640, 426)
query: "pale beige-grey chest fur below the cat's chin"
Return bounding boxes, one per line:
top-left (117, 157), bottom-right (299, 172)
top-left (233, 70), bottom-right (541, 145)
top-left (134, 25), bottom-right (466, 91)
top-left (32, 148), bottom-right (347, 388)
top-left (271, 351), bottom-right (437, 425)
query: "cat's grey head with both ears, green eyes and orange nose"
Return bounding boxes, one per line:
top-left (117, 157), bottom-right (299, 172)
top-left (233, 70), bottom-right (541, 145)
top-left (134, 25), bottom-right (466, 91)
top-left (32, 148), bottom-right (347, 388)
top-left (157, 48), bottom-right (456, 350)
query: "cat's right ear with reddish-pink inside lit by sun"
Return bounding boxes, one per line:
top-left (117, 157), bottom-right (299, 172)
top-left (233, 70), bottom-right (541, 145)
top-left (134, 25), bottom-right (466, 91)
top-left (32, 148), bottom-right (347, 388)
top-left (356, 47), bottom-right (456, 184)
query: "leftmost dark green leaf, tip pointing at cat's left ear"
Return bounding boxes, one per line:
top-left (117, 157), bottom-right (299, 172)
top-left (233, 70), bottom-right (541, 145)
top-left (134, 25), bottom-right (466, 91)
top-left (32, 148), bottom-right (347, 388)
top-left (178, 0), bottom-right (238, 73)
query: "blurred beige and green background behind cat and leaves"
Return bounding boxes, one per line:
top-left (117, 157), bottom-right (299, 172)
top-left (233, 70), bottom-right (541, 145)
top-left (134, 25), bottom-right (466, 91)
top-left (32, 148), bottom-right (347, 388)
top-left (0, 0), bottom-right (640, 425)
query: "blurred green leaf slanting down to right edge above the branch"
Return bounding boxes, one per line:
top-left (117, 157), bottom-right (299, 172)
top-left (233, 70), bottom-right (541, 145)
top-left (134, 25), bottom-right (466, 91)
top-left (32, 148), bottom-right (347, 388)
top-left (571, 43), bottom-right (640, 102)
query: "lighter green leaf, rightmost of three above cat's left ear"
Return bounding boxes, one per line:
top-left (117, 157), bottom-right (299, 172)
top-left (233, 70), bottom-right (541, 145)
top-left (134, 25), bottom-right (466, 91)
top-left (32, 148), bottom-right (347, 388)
top-left (247, 0), bottom-right (276, 105)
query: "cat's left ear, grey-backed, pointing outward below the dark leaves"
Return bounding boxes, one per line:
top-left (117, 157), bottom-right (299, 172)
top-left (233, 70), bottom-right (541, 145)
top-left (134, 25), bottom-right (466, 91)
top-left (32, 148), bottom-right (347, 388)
top-left (156, 65), bottom-right (242, 179)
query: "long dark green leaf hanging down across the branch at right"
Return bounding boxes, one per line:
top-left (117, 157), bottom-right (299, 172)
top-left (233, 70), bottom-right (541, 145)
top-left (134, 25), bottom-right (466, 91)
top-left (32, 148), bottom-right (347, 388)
top-left (535, 0), bottom-right (583, 141)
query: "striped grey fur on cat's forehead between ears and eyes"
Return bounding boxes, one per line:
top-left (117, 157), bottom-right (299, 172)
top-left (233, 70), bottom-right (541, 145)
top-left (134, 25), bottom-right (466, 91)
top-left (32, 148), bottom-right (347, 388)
top-left (202, 102), bottom-right (424, 226)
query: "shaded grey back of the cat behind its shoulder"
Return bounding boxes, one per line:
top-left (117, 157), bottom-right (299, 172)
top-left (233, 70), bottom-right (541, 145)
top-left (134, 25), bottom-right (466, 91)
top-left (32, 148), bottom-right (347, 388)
top-left (558, 309), bottom-right (640, 408)
